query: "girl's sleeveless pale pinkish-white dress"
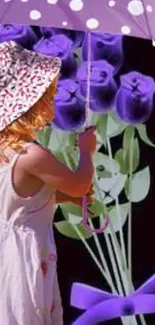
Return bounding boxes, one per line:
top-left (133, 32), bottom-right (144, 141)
top-left (0, 146), bottom-right (63, 325)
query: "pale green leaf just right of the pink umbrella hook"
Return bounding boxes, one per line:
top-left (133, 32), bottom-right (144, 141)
top-left (103, 203), bottom-right (130, 234)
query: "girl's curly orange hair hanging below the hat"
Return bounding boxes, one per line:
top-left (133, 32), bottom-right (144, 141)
top-left (0, 77), bottom-right (58, 162)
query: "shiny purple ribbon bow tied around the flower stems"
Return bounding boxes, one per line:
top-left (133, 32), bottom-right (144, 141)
top-left (71, 275), bottom-right (155, 325)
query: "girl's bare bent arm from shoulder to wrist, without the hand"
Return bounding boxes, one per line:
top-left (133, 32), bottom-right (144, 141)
top-left (22, 143), bottom-right (94, 198)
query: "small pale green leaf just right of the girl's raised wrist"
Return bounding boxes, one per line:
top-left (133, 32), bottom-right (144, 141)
top-left (93, 152), bottom-right (119, 173)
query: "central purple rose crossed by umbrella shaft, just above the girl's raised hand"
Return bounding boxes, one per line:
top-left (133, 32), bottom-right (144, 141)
top-left (77, 61), bottom-right (117, 113)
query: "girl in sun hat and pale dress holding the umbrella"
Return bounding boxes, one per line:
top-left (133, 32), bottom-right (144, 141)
top-left (0, 42), bottom-right (96, 325)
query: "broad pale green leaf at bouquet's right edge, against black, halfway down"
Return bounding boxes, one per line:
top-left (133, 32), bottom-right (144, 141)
top-left (125, 167), bottom-right (150, 202)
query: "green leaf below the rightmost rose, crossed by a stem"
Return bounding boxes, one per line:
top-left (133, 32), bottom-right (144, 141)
top-left (115, 139), bottom-right (140, 174)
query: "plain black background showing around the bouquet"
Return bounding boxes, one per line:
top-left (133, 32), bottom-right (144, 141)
top-left (54, 37), bottom-right (155, 325)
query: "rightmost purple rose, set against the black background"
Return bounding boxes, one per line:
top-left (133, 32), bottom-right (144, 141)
top-left (116, 71), bottom-right (155, 124)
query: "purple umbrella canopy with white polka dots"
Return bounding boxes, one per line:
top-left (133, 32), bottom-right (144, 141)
top-left (0, 0), bottom-right (155, 40)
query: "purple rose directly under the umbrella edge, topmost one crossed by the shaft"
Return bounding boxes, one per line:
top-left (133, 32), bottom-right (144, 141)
top-left (82, 33), bottom-right (123, 72)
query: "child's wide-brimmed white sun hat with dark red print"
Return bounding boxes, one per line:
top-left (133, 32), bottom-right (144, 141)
top-left (0, 41), bottom-right (61, 131)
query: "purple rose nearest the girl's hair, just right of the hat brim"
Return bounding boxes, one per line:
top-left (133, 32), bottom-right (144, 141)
top-left (52, 79), bottom-right (86, 131)
